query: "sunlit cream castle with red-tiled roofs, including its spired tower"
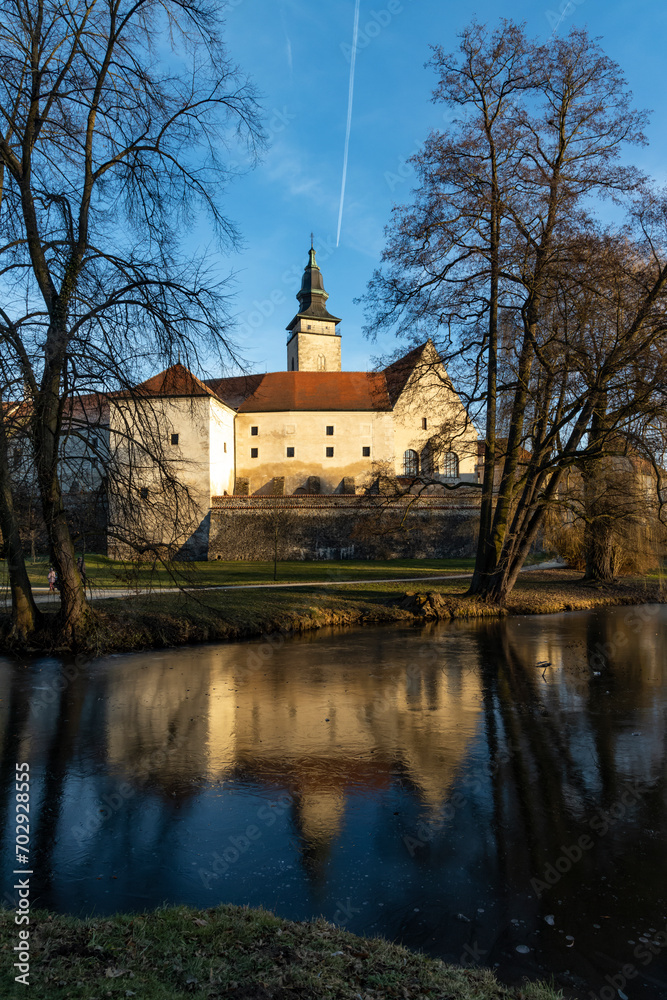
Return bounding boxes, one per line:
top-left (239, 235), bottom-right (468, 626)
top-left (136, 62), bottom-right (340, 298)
top-left (105, 247), bottom-right (478, 556)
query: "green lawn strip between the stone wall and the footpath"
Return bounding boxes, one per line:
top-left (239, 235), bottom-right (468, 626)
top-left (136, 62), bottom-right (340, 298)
top-left (0, 553), bottom-right (482, 589)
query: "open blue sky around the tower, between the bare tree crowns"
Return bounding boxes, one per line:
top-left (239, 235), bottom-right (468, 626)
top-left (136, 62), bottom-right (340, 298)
top-left (213, 0), bottom-right (667, 371)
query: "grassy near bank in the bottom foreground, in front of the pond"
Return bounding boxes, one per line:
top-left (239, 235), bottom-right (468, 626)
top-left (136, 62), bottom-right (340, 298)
top-left (0, 906), bottom-right (562, 1000)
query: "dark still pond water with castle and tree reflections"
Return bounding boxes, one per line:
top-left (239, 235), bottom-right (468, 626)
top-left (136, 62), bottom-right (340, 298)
top-left (0, 605), bottom-right (667, 1000)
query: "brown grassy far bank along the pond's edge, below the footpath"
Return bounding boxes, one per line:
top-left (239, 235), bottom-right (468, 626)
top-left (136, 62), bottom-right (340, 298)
top-left (0, 568), bottom-right (667, 656)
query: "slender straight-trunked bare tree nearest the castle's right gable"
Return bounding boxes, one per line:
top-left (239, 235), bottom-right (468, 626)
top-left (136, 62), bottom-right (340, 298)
top-left (368, 20), bottom-right (544, 576)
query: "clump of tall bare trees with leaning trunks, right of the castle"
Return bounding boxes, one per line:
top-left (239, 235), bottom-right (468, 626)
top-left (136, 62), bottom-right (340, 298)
top-left (369, 22), bottom-right (667, 603)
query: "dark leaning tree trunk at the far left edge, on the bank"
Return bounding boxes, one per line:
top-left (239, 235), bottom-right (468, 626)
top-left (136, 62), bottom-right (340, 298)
top-left (0, 400), bottom-right (41, 640)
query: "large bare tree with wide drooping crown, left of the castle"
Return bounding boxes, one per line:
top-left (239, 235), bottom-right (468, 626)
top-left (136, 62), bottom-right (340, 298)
top-left (0, 0), bottom-right (262, 632)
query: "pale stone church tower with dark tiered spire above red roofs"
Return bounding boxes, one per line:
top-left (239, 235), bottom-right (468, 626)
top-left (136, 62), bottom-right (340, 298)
top-left (287, 240), bottom-right (340, 372)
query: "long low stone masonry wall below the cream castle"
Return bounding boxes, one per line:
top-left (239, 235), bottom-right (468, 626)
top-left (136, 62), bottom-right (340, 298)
top-left (208, 491), bottom-right (479, 560)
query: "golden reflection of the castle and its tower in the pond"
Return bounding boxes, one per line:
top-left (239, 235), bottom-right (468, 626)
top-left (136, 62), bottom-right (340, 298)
top-left (106, 628), bottom-right (481, 842)
